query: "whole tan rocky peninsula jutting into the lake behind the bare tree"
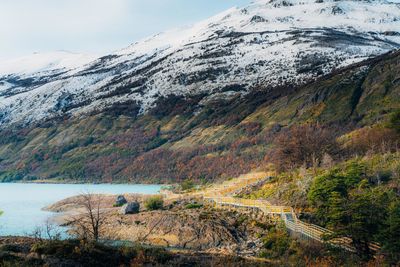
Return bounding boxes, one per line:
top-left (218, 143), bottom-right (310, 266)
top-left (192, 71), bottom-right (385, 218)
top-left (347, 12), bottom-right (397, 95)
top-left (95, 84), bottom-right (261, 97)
top-left (45, 194), bottom-right (267, 257)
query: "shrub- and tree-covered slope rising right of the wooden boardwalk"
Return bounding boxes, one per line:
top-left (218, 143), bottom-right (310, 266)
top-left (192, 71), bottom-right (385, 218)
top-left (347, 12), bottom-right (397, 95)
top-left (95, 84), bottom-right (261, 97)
top-left (248, 111), bottom-right (400, 265)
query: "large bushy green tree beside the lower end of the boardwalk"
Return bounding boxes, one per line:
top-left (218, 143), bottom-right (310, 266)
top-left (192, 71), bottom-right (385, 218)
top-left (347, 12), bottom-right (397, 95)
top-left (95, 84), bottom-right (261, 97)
top-left (308, 163), bottom-right (392, 259)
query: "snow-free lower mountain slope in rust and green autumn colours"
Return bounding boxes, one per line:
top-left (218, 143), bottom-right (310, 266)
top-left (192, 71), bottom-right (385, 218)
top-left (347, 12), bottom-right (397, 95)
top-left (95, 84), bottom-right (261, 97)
top-left (0, 49), bottom-right (400, 182)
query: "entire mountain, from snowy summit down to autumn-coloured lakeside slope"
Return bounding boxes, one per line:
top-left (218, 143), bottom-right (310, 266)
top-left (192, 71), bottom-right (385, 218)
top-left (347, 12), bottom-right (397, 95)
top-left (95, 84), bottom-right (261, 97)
top-left (0, 0), bottom-right (400, 183)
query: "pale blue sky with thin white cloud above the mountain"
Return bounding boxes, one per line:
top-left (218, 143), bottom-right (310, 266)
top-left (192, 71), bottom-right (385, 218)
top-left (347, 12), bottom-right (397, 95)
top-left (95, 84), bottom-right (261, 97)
top-left (0, 0), bottom-right (250, 60)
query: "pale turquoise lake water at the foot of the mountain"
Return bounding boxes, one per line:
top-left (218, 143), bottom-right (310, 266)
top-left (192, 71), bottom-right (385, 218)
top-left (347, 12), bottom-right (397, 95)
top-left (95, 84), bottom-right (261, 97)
top-left (0, 183), bottom-right (161, 236)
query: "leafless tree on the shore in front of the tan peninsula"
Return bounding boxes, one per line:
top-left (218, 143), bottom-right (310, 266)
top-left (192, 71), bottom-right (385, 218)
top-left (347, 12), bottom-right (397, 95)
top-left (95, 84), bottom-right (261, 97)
top-left (68, 193), bottom-right (107, 242)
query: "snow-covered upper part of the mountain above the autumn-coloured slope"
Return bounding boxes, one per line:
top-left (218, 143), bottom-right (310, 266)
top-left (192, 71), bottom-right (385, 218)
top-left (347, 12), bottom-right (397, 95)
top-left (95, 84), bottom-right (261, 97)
top-left (0, 0), bottom-right (400, 125)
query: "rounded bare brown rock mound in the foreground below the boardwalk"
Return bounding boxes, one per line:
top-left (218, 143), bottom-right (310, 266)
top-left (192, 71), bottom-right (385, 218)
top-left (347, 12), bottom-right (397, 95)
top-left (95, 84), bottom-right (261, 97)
top-left (108, 205), bottom-right (263, 256)
